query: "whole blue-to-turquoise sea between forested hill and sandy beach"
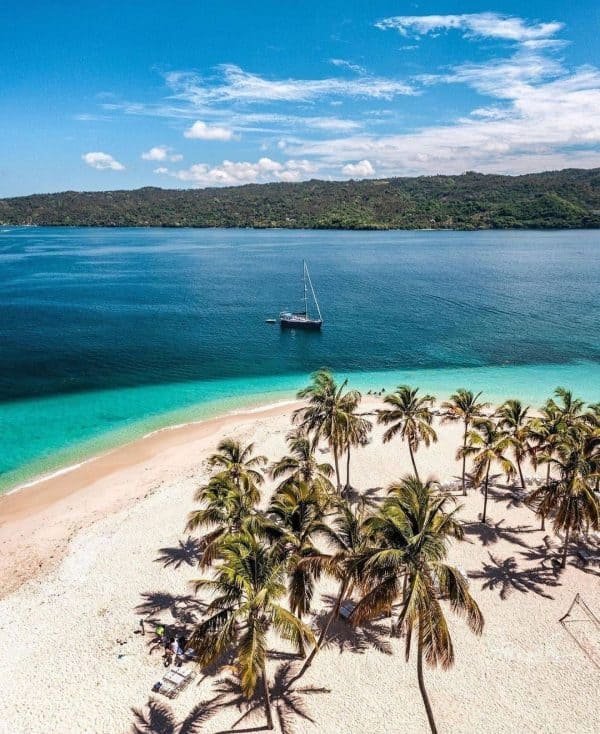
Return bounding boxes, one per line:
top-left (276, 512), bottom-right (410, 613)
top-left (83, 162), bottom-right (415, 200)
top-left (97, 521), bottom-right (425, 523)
top-left (0, 228), bottom-right (600, 490)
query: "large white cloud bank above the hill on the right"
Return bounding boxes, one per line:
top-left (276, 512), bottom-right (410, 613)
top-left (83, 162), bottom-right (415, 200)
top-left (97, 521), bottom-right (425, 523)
top-left (286, 63), bottom-right (600, 175)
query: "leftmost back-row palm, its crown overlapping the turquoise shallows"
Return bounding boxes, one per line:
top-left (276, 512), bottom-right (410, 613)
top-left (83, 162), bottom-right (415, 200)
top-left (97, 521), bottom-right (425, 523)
top-left (293, 369), bottom-right (361, 492)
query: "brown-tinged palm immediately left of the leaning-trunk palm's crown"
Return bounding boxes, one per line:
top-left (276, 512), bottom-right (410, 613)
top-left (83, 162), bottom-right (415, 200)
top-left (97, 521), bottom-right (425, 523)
top-left (267, 482), bottom-right (329, 657)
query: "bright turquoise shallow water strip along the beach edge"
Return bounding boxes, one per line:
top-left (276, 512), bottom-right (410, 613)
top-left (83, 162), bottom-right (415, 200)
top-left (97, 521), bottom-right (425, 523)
top-left (0, 362), bottom-right (600, 490)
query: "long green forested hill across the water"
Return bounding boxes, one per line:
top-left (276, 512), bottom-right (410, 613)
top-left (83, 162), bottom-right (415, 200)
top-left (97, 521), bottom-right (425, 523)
top-left (0, 168), bottom-right (600, 229)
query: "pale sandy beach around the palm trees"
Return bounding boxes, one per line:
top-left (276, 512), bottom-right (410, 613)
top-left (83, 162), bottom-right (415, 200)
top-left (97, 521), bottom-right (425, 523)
top-left (0, 400), bottom-right (600, 734)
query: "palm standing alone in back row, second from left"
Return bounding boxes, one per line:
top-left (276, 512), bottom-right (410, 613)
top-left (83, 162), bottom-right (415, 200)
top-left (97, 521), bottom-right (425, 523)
top-left (377, 385), bottom-right (437, 478)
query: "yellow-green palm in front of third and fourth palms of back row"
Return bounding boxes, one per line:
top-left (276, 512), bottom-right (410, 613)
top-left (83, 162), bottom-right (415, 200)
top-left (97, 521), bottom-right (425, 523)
top-left (464, 418), bottom-right (515, 522)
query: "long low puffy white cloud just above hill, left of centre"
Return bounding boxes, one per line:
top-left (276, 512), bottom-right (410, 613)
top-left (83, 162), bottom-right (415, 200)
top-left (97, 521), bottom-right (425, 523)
top-left (155, 157), bottom-right (318, 187)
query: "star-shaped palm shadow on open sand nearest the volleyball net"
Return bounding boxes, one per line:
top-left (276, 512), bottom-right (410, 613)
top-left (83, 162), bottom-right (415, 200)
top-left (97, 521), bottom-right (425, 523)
top-left (469, 551), bottom-right (560, 600)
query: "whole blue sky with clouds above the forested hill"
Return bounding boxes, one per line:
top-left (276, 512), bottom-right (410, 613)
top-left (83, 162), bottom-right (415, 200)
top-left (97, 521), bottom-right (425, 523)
top-left (0, 0), bottom-right (600, 196)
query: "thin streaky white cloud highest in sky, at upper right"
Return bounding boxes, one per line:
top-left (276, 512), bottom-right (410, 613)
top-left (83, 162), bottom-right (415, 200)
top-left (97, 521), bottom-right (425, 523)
top-left (375, 13), bottom-right (564, 43)
